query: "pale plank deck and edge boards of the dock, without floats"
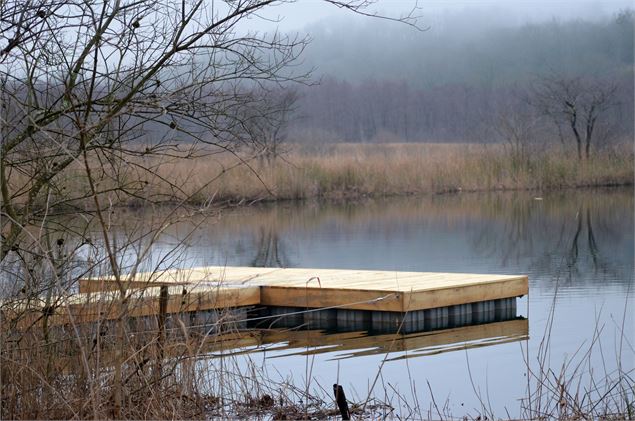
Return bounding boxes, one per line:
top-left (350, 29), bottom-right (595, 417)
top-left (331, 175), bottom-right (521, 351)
top-left (80, 266), bottom-right (528, 312)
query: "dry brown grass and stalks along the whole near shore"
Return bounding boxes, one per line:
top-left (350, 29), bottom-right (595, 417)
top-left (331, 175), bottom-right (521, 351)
top-left (0, 288), bottom-right (635, 420)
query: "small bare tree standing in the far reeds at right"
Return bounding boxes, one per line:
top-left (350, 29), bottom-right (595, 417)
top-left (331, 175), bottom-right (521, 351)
top-left (532, 77), bottom-right (617, 159)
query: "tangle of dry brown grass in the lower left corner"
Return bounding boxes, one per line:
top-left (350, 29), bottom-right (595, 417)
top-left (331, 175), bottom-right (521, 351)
top-left (0, 296), bottom-right (373, 419)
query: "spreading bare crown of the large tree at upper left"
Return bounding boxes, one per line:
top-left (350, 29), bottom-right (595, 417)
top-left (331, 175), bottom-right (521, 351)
top-left (0, 0), bottom-right (422, 263)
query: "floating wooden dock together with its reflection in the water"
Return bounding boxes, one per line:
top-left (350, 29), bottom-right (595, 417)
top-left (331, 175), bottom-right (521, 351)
top-left (0, 267), bottom-right (529, 365)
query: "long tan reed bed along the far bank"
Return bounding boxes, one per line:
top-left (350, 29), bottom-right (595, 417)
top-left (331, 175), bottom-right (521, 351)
top-left (9, 143), bottom-right (635, 207)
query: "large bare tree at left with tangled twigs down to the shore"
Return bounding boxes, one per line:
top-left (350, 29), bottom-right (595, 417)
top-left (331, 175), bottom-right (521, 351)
top-left (0, 0), bottom-right (422, 418)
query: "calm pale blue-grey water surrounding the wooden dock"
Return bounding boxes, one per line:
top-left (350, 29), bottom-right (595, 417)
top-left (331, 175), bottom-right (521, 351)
top-left (121, 189), bottom-right (635, 416)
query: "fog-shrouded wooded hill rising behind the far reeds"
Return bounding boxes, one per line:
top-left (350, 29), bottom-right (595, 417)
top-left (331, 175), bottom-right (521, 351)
top-left (280, 2), bottom-right (633, 142)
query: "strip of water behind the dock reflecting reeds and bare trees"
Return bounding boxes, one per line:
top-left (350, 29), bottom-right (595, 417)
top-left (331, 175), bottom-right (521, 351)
top-left (189, 189), bottom-right (633, 285)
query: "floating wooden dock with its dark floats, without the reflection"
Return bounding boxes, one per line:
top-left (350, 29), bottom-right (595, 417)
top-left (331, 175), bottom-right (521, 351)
top-left (7, 266), bottom-right (528, 332)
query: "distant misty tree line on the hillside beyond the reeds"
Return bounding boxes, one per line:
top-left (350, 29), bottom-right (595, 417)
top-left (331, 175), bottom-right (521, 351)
top-left (288, 11), bottom-right (634, 148)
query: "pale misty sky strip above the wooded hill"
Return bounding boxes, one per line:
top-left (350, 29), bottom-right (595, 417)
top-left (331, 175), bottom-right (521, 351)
top-left (242, 0), bottom-right (633, 32)
